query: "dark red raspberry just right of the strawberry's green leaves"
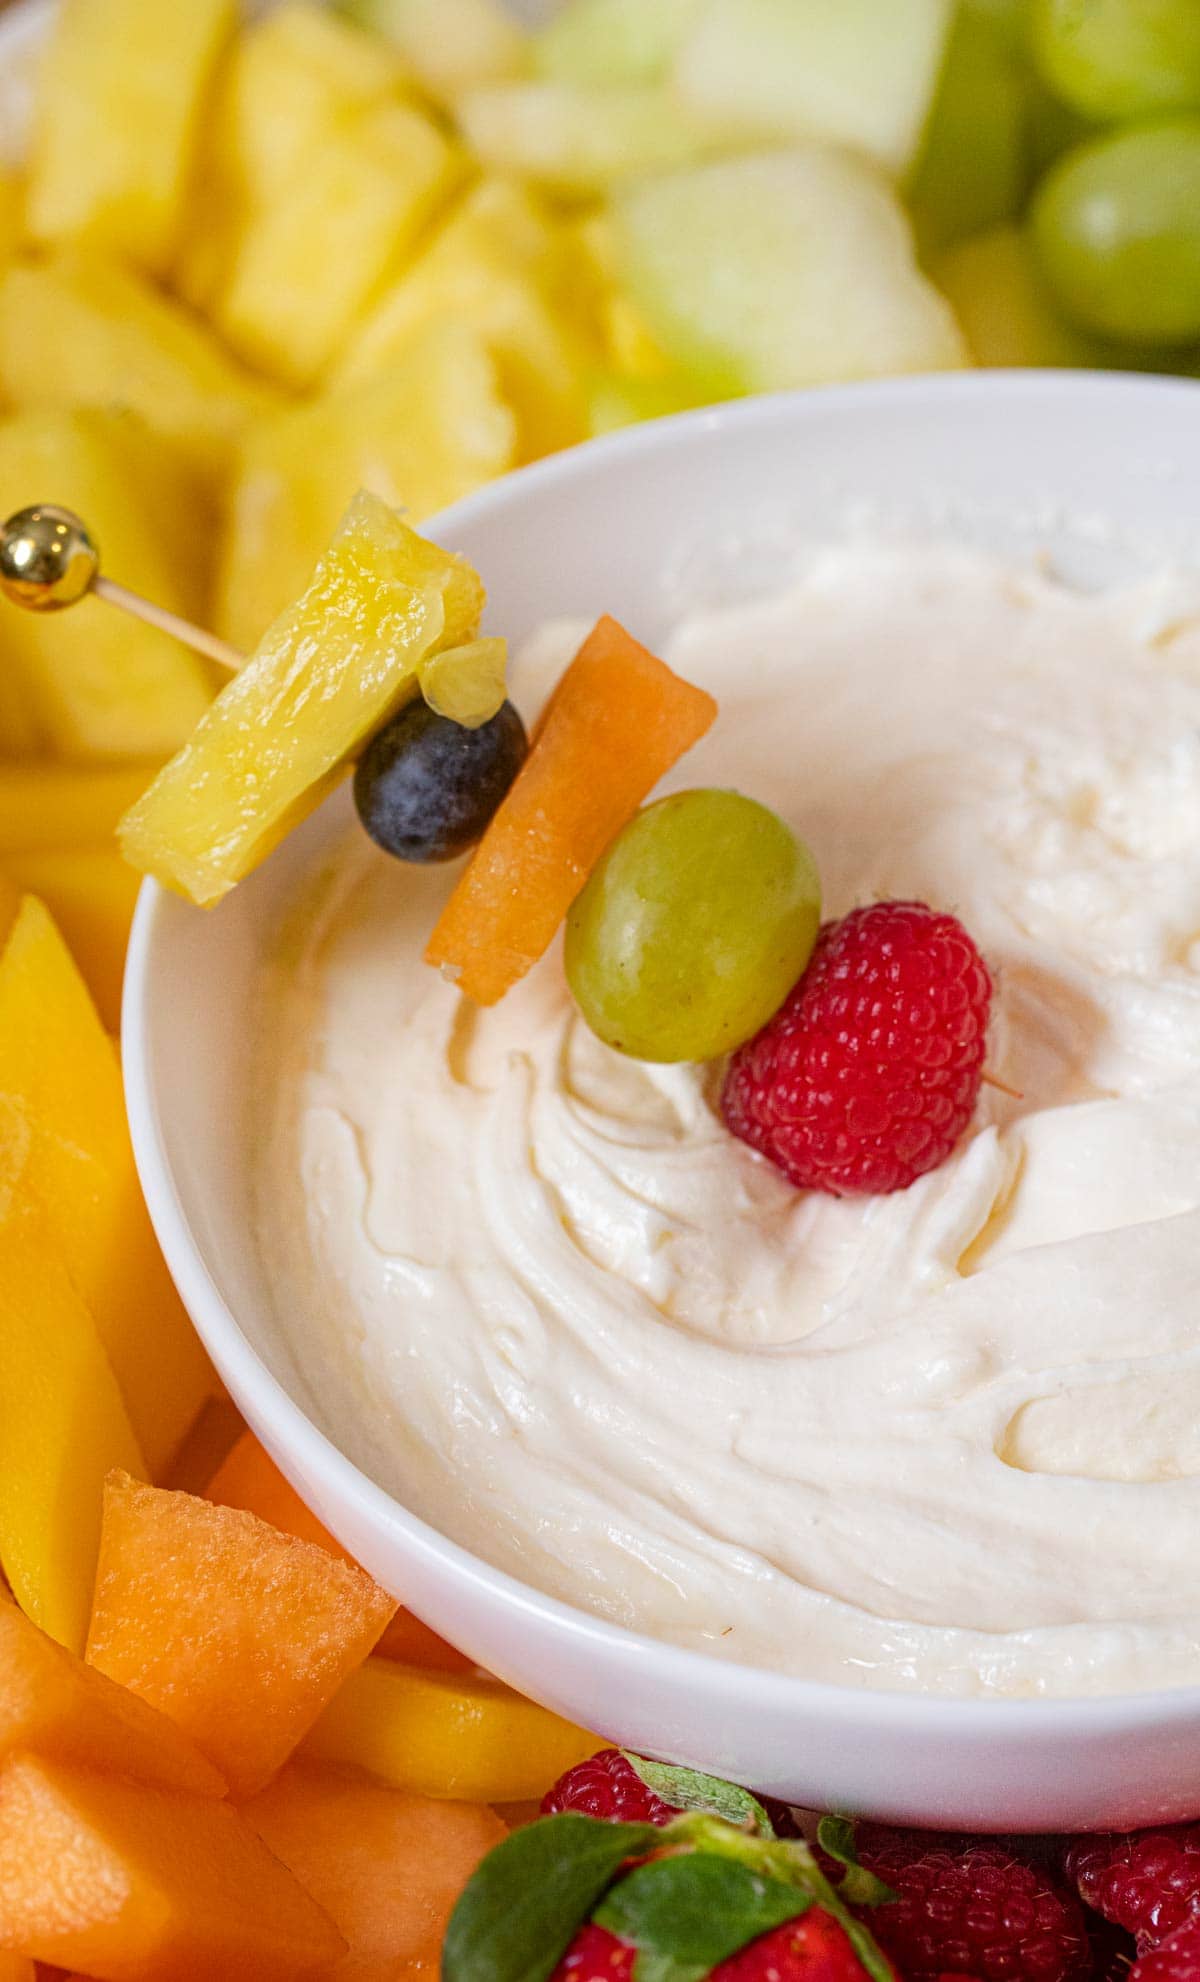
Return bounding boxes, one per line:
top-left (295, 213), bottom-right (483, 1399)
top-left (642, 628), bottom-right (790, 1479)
top-left (857, 1825), bottom-right (1086, 1982)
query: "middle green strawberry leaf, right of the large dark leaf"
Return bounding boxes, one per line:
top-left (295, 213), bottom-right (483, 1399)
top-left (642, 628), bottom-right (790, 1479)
top-left (593, 1851), bottom-right (813, 1982)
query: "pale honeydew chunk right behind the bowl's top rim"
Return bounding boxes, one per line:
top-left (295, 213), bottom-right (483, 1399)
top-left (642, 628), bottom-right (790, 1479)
top-left (615, 145), bottom-right (966, 396)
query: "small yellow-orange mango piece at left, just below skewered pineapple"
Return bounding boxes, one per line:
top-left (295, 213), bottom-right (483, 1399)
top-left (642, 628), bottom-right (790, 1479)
top-left (0, 846), bottom-right (139, 1035)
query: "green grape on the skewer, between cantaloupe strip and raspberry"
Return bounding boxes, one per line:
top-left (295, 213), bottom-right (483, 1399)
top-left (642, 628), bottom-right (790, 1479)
top-left (565, 791), bottom-right (821, 1060)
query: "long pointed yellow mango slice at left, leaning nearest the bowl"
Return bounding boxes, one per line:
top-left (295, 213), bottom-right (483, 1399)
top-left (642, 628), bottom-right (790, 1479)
top-left (0, 896), bottom-right (214, 1475)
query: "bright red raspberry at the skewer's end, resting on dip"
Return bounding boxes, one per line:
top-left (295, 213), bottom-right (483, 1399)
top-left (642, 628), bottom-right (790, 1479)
top-left (720, 902), bottom-right (992, 1197)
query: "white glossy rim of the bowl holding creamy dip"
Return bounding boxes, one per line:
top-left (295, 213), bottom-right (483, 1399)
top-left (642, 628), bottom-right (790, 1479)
top-left (121, 371), bottom-right (1200, 1748)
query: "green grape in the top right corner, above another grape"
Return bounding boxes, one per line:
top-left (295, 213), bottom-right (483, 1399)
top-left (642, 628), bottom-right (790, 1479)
top-left (1029, 0), bottom-right (1200, 121)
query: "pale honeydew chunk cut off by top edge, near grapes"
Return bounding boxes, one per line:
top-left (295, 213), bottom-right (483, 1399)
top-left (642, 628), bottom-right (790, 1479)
top-left (674, 0), bottom-right (954, 174)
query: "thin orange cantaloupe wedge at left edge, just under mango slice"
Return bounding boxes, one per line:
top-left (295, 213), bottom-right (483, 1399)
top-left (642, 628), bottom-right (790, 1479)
top-left (0, 1603), bottom-right (226, 1796)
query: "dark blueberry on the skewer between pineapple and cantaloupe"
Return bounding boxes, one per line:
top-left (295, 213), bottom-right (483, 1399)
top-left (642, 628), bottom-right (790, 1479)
top-left (355, 700), bottom-right (530, 860)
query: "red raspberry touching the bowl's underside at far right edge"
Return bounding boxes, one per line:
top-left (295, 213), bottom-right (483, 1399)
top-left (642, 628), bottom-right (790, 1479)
top-left (1067, 1823), bottom-right (1200, 1954)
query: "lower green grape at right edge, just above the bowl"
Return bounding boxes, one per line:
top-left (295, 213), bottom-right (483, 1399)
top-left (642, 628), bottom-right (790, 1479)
top-left (1031, 117), bottom-right (1200, 347)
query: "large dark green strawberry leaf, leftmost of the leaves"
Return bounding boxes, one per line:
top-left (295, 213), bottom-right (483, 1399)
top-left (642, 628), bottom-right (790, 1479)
top-left (442, 1812), bottom-right (664, 1982)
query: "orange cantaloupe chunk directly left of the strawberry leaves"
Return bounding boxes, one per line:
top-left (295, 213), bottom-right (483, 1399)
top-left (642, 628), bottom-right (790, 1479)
top-left (242, 1762), bottom-right (508, 1982)
